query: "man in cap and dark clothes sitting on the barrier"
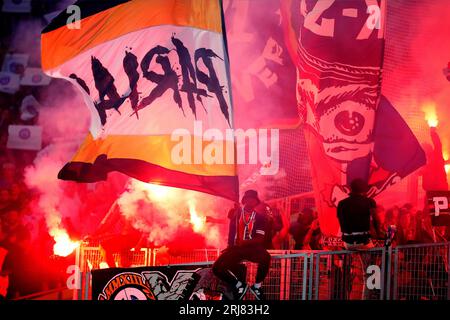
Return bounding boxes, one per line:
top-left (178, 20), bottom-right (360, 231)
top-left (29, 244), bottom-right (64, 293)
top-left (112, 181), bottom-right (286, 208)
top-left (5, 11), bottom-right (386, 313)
top-left (212, 190), bottom-right (270, 300)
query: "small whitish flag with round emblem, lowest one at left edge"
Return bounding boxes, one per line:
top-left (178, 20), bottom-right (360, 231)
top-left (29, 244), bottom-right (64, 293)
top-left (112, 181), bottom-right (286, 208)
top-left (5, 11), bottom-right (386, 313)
top-left (6, 125), bottom-right (42, 150)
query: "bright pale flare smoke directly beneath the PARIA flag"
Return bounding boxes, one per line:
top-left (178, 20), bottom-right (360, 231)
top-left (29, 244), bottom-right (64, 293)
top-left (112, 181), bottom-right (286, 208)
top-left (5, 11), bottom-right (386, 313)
top-left (118, 179), bottom-right (231, 250)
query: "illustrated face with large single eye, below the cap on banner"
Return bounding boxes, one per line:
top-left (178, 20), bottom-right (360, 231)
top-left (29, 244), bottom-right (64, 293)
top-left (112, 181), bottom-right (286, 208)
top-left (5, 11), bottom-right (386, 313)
top-left (297, 79), bottom-right (377, 162)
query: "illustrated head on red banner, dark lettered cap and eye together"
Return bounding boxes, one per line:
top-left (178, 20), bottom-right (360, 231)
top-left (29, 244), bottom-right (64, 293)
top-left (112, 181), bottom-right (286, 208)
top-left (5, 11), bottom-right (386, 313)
top-left (297, 0), bottom-right (383, 163)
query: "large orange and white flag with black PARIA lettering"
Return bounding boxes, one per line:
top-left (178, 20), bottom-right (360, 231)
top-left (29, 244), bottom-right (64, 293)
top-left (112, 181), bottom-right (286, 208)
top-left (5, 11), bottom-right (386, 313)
top-left (42, 0), bottom-right (238, 200)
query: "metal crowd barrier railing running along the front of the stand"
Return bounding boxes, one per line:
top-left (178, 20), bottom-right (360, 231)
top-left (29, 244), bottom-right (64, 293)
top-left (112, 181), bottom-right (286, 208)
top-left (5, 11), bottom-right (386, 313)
top-left (74, 243), bottom-right (450, 300)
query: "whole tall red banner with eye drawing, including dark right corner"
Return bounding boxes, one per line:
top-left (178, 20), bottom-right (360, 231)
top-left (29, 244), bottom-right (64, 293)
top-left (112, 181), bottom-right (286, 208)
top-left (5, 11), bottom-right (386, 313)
top-left (281, 0), bottom-right (425, 236)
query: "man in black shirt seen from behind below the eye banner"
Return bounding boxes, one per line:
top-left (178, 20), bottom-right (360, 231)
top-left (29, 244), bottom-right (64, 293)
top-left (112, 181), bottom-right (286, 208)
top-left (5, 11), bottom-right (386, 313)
top-left (337, 179), bottom-right (380, 249)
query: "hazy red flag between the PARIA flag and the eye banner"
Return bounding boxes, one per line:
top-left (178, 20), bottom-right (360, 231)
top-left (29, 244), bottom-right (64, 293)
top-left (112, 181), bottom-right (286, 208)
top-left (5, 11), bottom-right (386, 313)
top-left (223, 0), bottom-right (299, 128)
